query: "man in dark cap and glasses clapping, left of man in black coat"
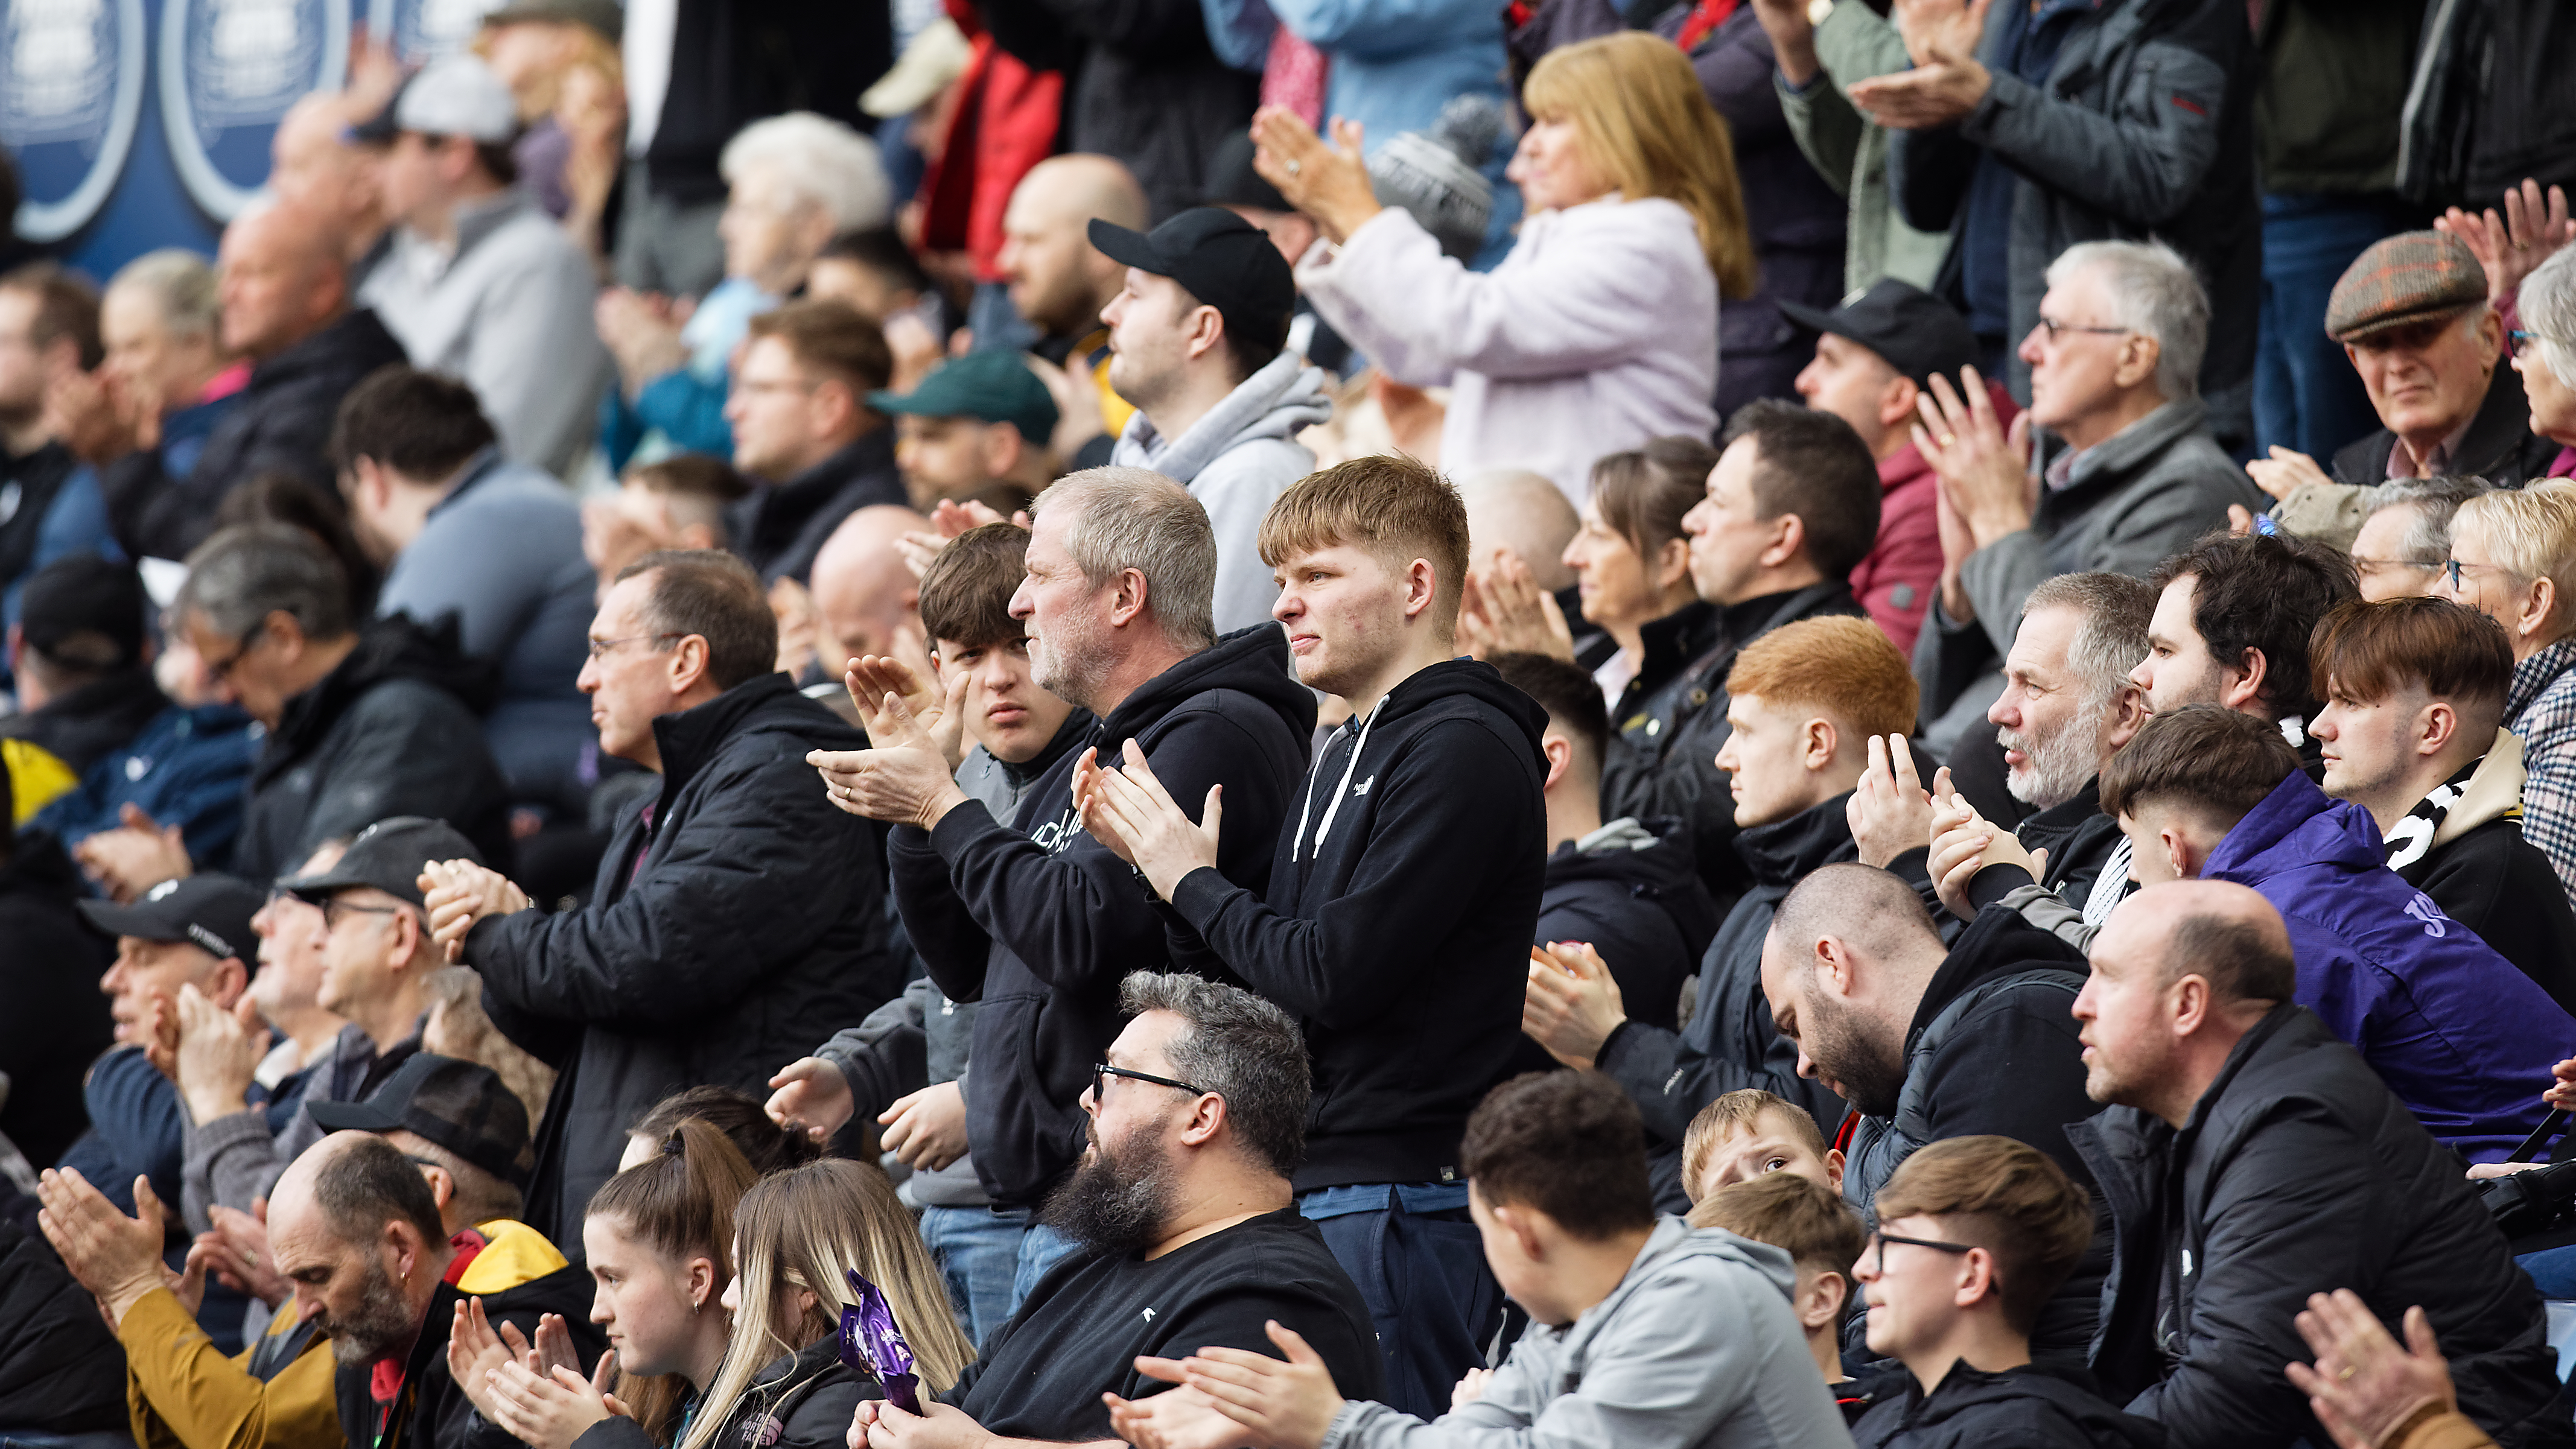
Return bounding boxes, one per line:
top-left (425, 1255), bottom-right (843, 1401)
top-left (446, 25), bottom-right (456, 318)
top-left (178, 816), bottom-right (482, 1228)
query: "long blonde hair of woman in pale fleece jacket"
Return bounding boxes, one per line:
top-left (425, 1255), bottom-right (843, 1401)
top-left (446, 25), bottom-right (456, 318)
top-left (1520, 31), bottom-right (1760, 296)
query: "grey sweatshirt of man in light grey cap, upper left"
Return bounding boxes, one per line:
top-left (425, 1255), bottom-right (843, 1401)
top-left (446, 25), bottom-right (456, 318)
top-left (358, 191), bottom-right (608, 476)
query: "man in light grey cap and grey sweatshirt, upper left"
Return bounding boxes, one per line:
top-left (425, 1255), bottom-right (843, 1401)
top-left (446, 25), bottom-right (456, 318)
top-left (358, 54), bottom-right (608, 474)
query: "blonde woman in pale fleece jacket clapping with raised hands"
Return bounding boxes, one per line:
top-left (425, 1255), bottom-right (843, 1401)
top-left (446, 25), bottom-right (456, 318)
top-left (1252, 31), bottom-right (1754, 504)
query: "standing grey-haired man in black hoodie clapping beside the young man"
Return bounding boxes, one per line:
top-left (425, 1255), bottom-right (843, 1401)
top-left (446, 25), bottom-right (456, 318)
top-left (809, 468), bottom-right (1314, 1300)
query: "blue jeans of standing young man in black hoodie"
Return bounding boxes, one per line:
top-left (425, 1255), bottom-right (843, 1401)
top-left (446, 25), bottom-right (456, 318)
top-left (1299, 1184), bottom-right (1502, 1418)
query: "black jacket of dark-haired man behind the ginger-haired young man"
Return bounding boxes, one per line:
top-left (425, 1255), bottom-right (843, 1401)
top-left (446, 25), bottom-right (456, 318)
top-left (1602, 579), bottom-right (1868, 906)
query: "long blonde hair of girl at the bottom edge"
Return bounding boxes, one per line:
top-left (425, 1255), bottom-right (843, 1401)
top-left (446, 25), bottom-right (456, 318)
top-left (680, 1158), bottom-right (974, 1449)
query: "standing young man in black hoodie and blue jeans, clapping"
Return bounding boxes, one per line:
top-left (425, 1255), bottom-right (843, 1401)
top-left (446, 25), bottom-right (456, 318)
top-left (1081, 455), bottom-right (1548, 1416)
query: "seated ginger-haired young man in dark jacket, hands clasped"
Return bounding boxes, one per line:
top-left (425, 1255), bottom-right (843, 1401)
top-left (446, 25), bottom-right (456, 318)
top-left (1522, 618), bottom-right (1914, 1210)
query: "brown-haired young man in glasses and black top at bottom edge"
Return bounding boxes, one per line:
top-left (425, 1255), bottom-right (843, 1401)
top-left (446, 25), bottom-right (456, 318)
top-left (1852, 1138), bottom-right (2164, 1449)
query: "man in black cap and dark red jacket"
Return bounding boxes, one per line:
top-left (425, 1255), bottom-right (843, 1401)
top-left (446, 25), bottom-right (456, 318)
top-left (1780, 278), bottom-right (2020, 651)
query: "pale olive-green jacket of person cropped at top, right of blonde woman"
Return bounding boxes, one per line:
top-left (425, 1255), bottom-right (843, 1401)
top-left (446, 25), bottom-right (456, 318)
top-left (1772, 0), bottom-right (1950, 291)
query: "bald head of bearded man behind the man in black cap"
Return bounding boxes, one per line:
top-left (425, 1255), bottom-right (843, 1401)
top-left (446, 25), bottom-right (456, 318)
top-left (994, 154), bottom-right (1151, 337)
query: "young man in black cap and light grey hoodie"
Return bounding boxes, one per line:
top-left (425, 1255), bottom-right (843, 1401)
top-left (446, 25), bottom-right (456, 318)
top-left (1090, 206), bottom-right (1332, 633)
